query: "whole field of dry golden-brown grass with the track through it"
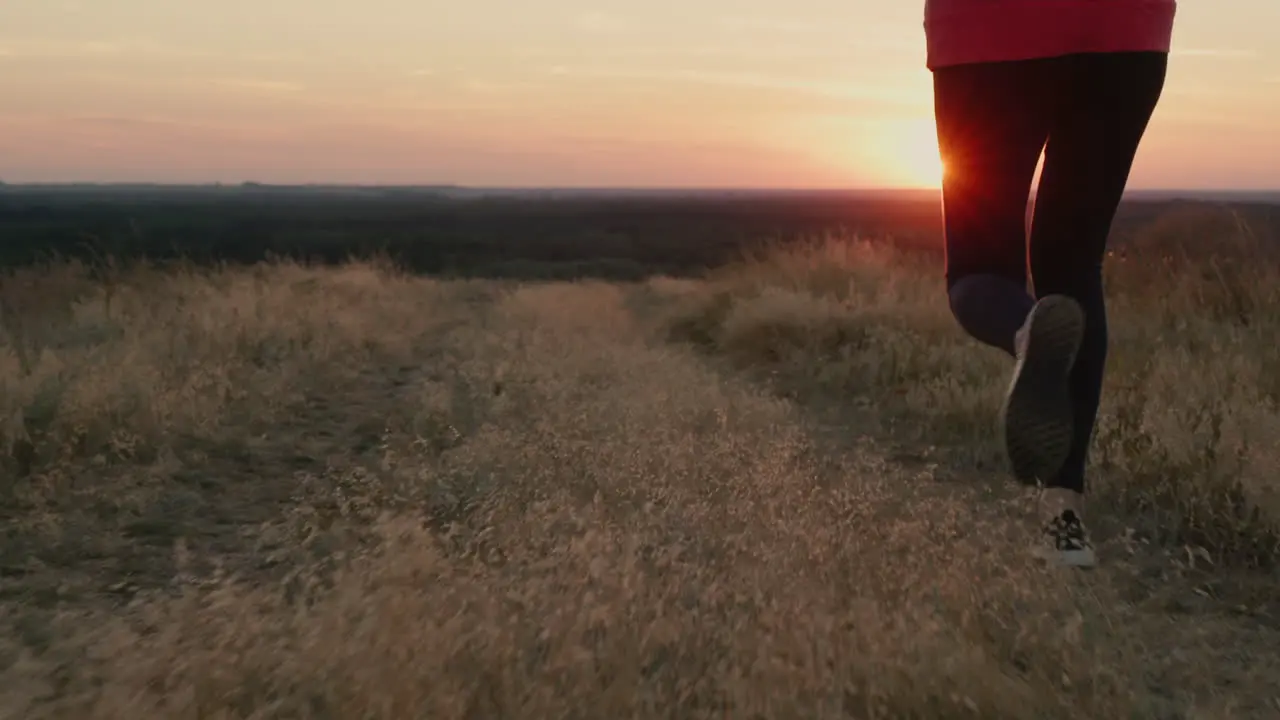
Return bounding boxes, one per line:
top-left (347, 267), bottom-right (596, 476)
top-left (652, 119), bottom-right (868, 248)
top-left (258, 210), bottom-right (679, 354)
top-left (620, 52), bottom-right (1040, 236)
top-left (0, 233), bottom-right (1280, 720)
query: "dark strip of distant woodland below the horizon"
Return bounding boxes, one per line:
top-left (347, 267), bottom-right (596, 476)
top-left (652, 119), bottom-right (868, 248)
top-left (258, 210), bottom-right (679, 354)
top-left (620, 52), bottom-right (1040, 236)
top-left (0, 187), bottom-right (1280, 279)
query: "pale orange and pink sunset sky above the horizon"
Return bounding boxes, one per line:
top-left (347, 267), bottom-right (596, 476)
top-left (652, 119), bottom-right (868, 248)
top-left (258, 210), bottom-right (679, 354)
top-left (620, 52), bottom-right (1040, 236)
top-left (0, 0), bottom-right (1280, 190)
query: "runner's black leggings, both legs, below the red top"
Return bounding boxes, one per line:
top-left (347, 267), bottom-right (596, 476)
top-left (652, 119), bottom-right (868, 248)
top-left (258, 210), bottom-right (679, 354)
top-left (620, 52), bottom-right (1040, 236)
top-left (933, 53), bottom-right (1167, 492)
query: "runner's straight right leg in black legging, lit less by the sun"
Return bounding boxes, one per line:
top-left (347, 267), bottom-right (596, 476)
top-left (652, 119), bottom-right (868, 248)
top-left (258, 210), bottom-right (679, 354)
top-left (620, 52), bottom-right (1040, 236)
top-left (1030, 53), bottom-right (1167, 499)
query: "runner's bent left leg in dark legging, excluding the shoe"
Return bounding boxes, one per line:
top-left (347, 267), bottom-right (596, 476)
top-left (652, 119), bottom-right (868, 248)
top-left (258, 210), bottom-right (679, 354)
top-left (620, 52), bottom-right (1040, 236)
top-left (933, 60), bottom-right (1056, 355)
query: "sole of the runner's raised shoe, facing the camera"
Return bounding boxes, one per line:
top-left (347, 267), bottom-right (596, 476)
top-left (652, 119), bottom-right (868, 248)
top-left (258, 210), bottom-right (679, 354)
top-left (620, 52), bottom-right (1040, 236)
top-left (1002, 296), bottom-right (1084, 486)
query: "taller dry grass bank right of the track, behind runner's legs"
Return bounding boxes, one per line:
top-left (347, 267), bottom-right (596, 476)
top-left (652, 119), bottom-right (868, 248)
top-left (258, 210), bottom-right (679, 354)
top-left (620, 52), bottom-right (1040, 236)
top-left (672, 240), bottom-right (1280, 565)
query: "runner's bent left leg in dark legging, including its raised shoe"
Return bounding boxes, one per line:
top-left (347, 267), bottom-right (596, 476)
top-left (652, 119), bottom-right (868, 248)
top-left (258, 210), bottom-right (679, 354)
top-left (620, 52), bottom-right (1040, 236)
top-left (934, 58), bottom-right (1084, 484)
